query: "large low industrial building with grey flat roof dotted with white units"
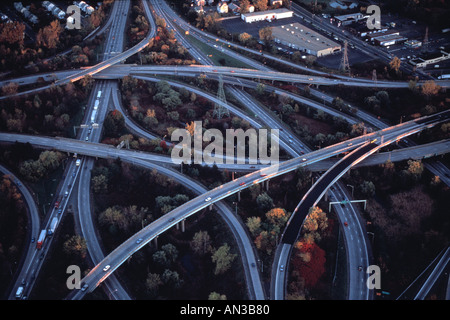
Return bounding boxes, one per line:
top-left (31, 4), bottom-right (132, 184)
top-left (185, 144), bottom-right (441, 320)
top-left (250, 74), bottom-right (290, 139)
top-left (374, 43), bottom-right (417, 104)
top-left (272, 23), bottom-right (341, 57)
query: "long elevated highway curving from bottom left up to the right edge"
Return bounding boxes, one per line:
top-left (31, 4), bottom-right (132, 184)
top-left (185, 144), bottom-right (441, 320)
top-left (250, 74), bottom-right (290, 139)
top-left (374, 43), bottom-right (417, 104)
top-left (59, 112), bottom-right (448, 299)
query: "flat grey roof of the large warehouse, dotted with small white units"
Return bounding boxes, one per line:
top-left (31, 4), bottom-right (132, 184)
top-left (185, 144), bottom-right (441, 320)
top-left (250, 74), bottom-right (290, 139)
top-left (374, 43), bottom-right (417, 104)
top-left (272, 23), bottom-right (341, 52)
